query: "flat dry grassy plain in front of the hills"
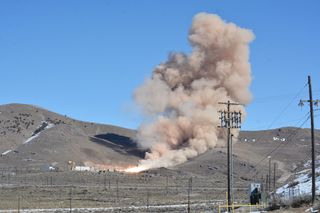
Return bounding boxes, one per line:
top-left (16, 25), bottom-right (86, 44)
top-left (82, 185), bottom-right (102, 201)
top-left (0, 168), bottom-right (248, 212)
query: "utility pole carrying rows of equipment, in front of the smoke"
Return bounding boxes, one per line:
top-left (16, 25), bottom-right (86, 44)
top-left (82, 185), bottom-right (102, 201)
top-left (219, 101), bottom-right (242, 212)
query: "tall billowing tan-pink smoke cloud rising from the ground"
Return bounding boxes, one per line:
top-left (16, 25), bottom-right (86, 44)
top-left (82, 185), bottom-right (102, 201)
top-left (135, 13), bottom-right (254, 169)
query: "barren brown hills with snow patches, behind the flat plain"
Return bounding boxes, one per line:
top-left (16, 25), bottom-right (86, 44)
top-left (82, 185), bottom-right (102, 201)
top-left (0, 104), bottom-right (320, 188)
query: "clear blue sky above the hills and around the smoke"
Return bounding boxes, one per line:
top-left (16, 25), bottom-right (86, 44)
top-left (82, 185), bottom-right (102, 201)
top-left (0, 0), bottom-right (320, 130)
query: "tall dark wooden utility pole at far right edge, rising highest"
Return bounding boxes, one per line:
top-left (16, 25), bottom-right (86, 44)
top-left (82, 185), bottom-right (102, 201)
top-left (299, 75), bottom-right (320, 203)
